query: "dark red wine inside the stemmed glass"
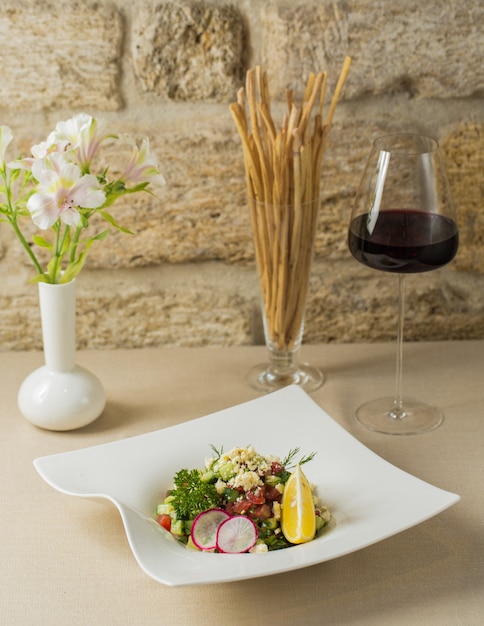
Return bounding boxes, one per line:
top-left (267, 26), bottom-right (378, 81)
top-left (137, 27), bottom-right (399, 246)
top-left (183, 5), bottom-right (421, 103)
top-left (348, 209), bottom-right (459, 274)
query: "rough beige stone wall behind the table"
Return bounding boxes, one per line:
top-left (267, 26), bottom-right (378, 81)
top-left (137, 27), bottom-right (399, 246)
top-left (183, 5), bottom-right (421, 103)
top-left (0, 0), bottom-right (484, 349)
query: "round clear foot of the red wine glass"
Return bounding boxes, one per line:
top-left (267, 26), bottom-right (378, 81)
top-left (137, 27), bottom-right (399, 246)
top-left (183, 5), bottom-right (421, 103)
top-left (356, 397), bottom-right (444, 435)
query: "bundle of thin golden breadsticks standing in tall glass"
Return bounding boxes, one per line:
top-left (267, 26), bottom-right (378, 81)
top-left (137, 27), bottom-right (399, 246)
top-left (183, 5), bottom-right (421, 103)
top-left (230, 57), bottom-right (351, 350)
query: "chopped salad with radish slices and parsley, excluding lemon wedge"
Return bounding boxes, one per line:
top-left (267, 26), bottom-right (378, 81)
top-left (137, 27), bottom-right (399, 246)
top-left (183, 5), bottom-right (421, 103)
top-left (156, 446), bottom-right (331, 553)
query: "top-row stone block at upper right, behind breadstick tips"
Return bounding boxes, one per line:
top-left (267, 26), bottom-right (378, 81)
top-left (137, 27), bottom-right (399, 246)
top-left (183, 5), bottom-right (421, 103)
top-left (262, 0), bottom-right (484, 99)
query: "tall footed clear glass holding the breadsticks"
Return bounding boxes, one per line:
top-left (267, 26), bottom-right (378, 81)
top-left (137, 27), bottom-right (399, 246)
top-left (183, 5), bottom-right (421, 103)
top-left (248, 198), bottom-right (323, 392)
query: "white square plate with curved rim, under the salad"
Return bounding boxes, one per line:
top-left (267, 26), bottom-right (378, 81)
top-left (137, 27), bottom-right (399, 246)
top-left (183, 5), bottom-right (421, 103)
top-left (34, 386), bottom-right (460, 586)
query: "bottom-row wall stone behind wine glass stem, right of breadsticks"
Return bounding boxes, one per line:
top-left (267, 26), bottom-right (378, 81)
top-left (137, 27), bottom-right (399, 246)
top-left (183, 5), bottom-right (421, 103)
top-left (304, 258), bottom-right (484, 343)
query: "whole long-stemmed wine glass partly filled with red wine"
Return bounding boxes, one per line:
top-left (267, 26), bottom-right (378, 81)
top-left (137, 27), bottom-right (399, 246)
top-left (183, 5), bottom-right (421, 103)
top-left (348, 134), bottom-right (459, 435)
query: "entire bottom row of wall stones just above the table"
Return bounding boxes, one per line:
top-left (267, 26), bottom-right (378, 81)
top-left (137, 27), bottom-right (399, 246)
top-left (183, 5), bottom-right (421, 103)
top-left (0, 258), bottom-right (484, 350)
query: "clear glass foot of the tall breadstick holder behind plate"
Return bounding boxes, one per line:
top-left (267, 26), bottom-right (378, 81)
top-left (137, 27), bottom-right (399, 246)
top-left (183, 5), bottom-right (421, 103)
top-left (246, 363), bottom-right (324, 393)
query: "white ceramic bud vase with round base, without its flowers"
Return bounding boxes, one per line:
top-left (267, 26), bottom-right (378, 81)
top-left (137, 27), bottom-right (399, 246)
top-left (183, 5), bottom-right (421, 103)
top-left (18, 280), bottom-right (106, 431)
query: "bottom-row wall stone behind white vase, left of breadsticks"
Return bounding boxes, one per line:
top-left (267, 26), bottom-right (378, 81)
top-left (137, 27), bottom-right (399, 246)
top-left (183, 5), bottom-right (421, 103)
top-left (0, 264), bottom-right (256, 350)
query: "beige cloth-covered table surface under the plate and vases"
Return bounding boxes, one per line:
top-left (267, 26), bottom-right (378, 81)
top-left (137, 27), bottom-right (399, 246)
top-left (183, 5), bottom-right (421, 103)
top-left (0, 341), bottom-right (484, 626)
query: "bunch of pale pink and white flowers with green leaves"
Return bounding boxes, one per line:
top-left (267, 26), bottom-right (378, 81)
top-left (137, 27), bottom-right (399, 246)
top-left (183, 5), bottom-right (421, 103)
top-left (0, 113), bottom-right (165, 284)
